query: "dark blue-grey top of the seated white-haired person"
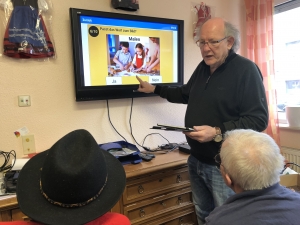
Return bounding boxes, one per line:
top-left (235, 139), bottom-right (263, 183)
top-left (205, 183), bottom-right (300, 225)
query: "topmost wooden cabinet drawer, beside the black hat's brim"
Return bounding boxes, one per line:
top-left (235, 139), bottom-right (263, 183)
top-left (123, 167), bottom-right (190, 204)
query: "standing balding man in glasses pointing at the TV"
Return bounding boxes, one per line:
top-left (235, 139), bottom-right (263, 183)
top-left (137, 18), bottom-right (268, 224)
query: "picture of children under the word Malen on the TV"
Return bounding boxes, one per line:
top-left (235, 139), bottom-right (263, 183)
top-left (107, 34), bottom-right (160, 76)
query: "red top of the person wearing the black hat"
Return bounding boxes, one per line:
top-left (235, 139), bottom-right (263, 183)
top-left (0, 212), bottom-right (130, 225)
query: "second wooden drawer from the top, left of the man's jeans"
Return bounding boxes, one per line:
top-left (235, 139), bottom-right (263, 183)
top-left (126, 192), bottom-right (193, 223)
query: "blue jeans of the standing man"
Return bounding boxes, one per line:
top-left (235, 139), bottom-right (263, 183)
top-left (188, 155), bottom-right (234, 225)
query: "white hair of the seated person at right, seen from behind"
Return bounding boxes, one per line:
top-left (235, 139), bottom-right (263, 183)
top-left (220, 129), bottom-right (284, 190)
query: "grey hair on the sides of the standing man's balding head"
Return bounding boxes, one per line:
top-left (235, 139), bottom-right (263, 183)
top-left (194, 19), bottom-right (241, 52)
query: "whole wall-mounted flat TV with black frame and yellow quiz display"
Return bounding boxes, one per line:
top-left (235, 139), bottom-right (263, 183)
top-left (70, 8), bottom-right (184, 101)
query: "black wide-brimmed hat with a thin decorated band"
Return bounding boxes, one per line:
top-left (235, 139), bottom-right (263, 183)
top-left (17, 130), bottom-right (126, 225)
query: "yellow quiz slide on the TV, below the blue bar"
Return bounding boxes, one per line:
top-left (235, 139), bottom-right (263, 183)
top-left (81, 20), bottom-right (177, 86)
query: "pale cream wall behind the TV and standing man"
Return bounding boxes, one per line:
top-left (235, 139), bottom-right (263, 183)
top-left (0, 0), bottom-right (245, 158)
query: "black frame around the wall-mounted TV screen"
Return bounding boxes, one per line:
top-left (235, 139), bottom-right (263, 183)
top-left (70, 8), bottom-right (184, 101)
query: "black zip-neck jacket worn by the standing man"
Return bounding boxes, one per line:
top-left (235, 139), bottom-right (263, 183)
top-left (154, 50), bottom-right (268, 164)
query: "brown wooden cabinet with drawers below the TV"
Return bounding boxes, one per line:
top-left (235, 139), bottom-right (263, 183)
top-left (0, 150), bottom-right (197, 225)
